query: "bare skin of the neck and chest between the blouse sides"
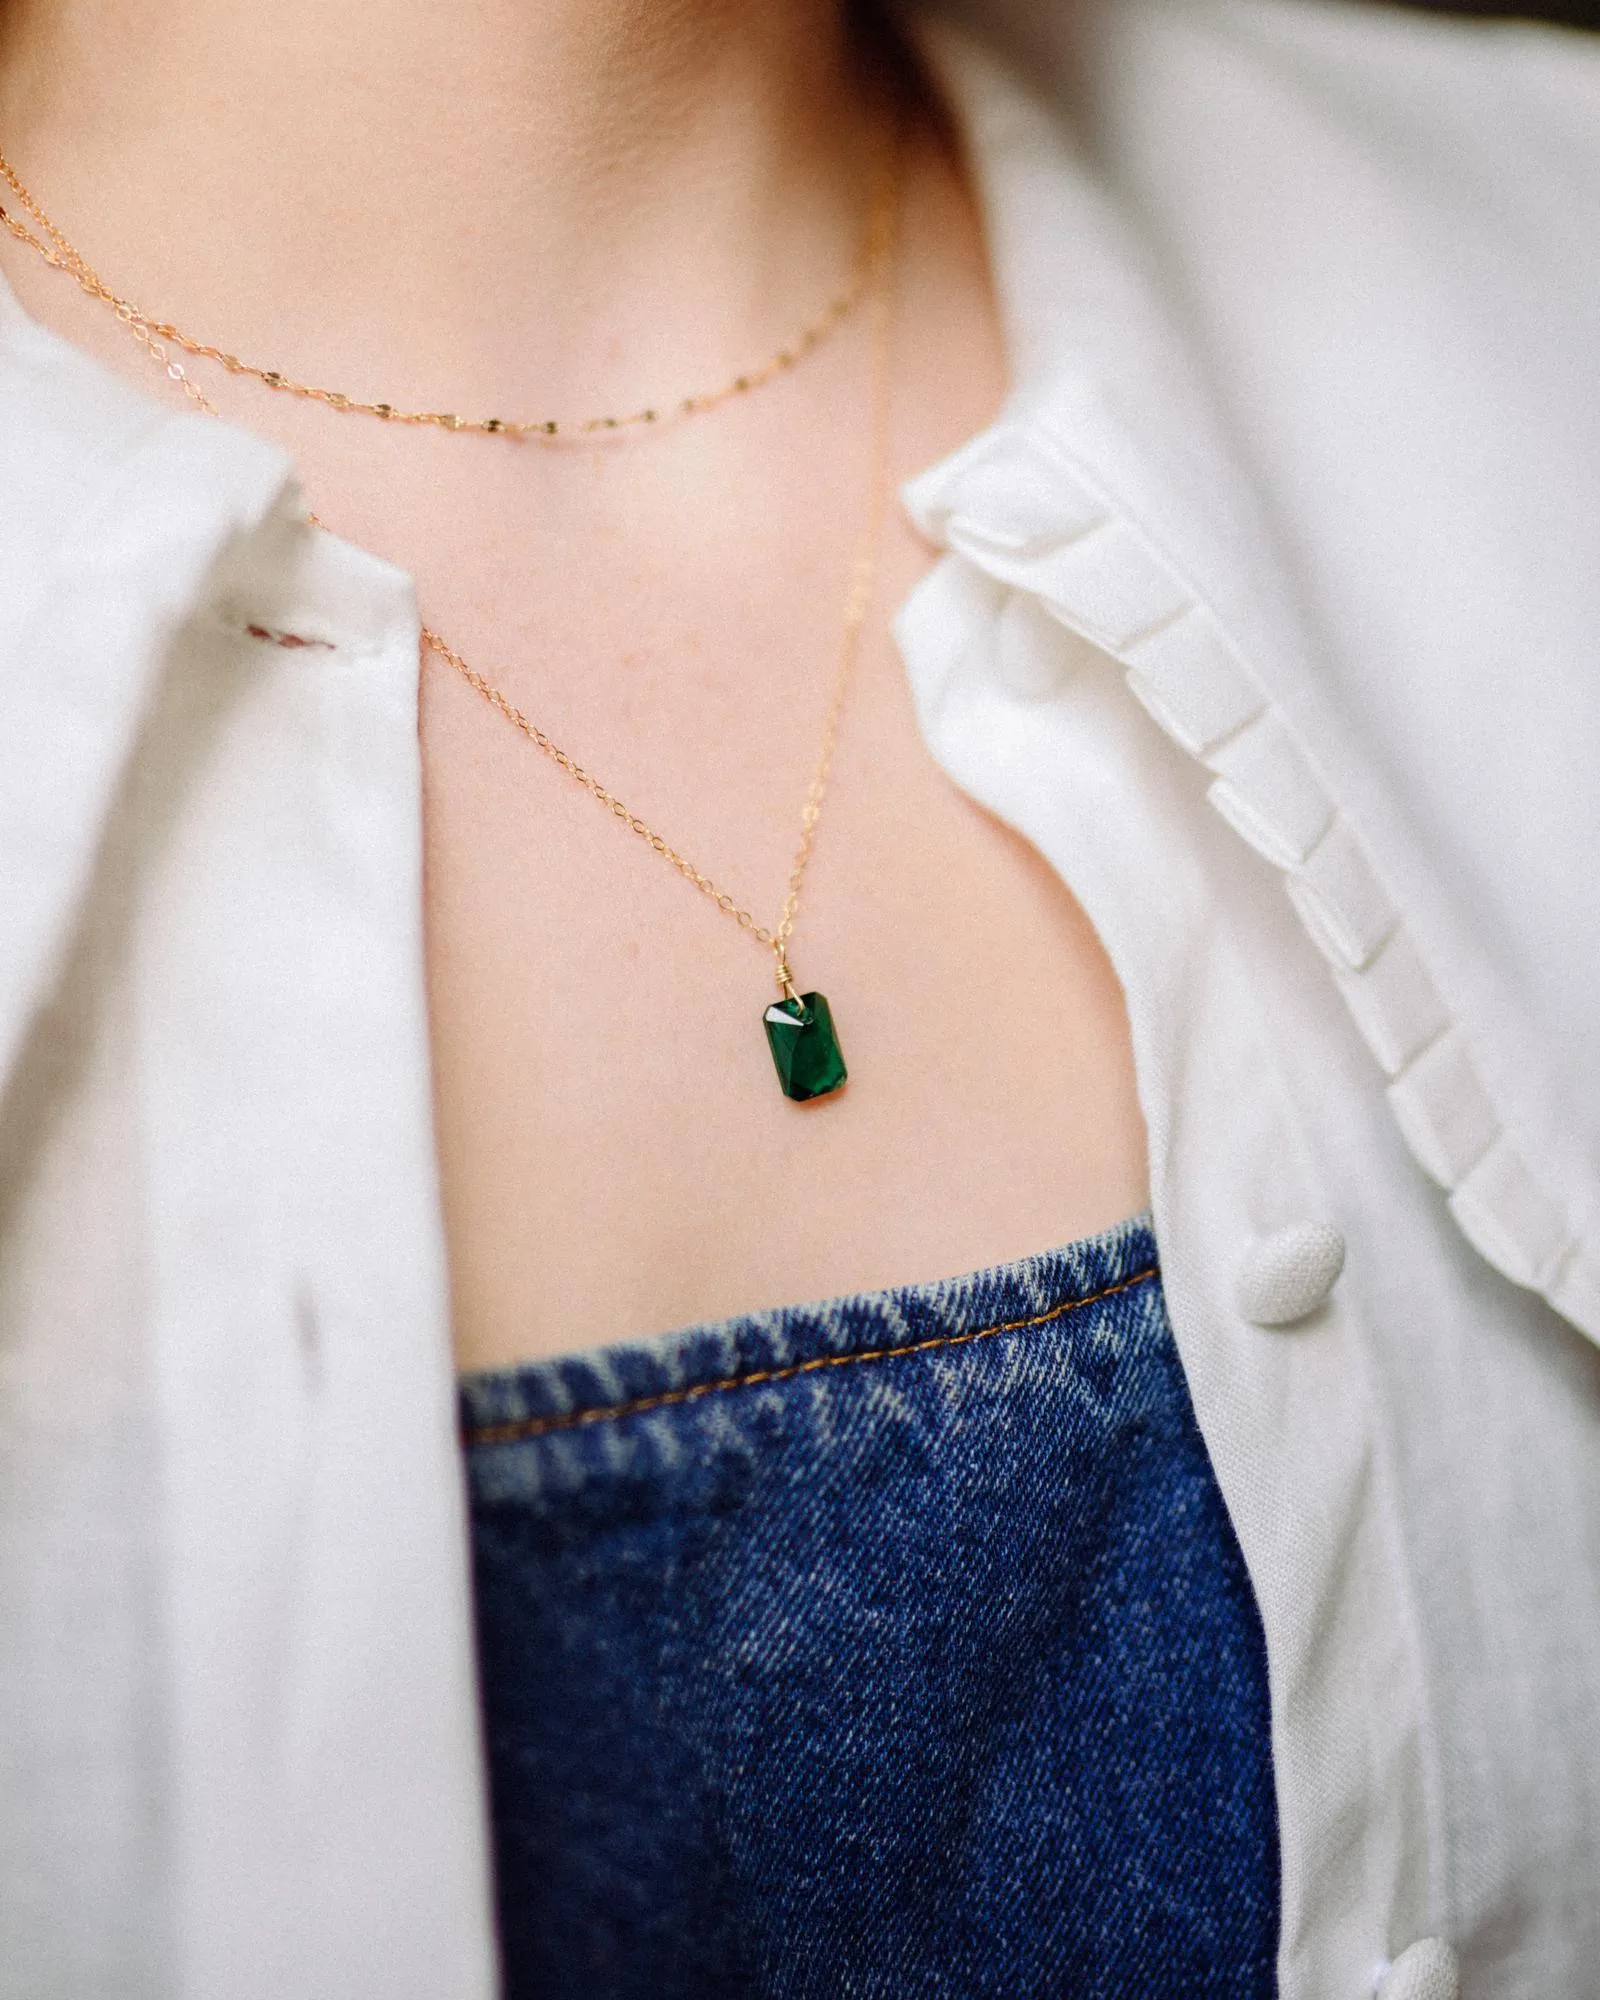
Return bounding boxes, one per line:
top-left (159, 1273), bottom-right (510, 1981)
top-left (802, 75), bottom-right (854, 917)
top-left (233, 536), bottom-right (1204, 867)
top-left (0, 0), bottom-right (1146, 1368)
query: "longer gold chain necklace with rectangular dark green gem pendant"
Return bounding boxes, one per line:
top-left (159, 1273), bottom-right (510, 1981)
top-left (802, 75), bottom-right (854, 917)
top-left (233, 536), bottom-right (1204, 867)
top-left (0, 148), bottom-right (900, 1100)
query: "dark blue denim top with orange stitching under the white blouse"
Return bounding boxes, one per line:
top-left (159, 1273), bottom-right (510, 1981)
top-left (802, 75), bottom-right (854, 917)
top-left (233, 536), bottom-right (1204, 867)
top-left (462, 1218), bottom-right (1278, 2000)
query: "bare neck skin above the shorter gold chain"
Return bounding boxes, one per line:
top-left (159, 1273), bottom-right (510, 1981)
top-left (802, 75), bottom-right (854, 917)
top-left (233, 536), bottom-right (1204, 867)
top-left (0, 0), bottom-right (866, 406)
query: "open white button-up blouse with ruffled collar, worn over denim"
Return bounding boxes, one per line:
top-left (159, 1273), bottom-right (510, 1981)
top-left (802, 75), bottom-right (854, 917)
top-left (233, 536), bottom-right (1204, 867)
top-left (0, 0), bottom-right (1600, 2000)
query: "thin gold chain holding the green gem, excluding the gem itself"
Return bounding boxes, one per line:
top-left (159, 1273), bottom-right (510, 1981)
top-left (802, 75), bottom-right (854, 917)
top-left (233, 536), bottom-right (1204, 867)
top-left (0, 131), bottom-right (900, 1000)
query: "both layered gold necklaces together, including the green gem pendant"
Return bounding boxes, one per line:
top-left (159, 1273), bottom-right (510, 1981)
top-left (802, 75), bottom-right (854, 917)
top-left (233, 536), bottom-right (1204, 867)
top-left (0, 136), bottom-right (900, 1100)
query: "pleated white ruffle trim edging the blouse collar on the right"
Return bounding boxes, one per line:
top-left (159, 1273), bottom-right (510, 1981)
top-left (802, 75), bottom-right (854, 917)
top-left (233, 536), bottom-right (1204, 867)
top-left (906, 422), bottom-right (1600, 1342)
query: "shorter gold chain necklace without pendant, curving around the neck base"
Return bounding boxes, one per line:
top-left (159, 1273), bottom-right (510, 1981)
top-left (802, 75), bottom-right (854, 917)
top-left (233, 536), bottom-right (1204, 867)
top-left (0, 146), bottom-right (896, 438)
